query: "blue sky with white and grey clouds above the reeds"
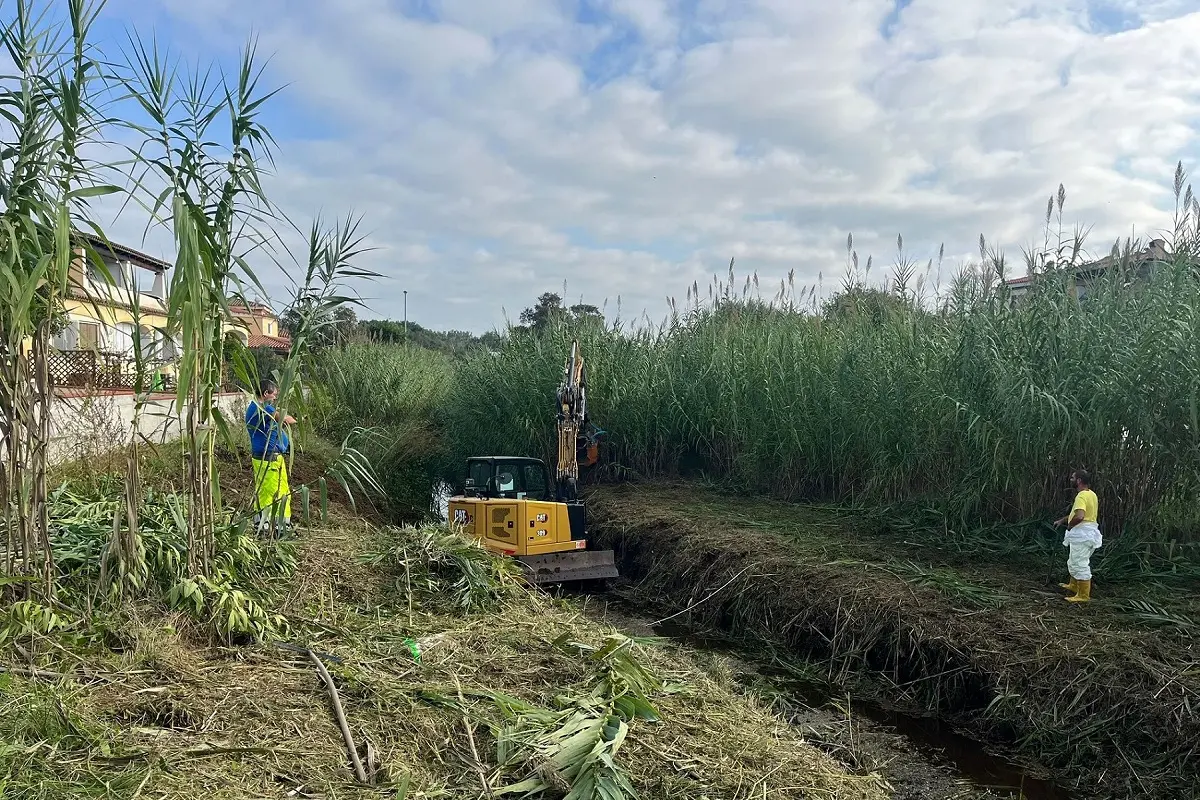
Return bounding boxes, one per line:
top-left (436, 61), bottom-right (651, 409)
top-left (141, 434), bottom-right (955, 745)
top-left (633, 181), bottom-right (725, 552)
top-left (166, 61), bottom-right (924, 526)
top-left (68, 0), bottom-right (1200, 332)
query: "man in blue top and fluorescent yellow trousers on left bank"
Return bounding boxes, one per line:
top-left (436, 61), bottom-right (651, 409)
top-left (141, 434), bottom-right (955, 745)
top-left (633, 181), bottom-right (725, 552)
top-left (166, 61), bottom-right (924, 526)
top-left (246, 380), bottom-right (295, 531)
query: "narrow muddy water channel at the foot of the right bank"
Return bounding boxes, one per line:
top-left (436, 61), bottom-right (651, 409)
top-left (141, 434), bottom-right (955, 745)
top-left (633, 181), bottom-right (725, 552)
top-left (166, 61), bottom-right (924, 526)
top-left (650, 622), bottom-right (1073, 800)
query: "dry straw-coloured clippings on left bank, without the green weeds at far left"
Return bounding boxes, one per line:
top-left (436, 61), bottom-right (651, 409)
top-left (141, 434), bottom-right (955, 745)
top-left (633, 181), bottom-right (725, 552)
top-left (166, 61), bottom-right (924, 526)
top-left (0, 506), bottom-right (888, 800)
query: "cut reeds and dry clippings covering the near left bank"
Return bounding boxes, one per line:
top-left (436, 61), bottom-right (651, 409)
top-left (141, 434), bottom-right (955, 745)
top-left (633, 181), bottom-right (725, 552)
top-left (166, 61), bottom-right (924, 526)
top-left (0, 472), bottom-right (888, 800)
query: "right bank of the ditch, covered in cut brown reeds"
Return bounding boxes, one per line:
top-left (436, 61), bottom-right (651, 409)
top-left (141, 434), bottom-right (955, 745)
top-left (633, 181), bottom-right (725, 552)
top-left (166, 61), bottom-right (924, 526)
top-left (588, 485), bottom-right (1200, 800)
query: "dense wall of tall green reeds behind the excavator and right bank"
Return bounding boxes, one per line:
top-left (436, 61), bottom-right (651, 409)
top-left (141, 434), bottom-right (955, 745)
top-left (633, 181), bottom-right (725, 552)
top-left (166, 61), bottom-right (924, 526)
top-left (445, 170), bottom-right (1200, 551)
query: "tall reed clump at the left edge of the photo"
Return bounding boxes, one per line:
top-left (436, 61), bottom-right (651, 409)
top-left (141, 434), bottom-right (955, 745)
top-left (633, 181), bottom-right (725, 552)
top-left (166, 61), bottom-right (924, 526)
top-left (0, 0), bottom-right (114, 595)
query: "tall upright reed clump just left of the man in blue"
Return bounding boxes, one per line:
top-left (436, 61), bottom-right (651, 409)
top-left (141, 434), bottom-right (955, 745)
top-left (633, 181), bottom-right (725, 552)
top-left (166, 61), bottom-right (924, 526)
top-left (120, 32), bottom-right (284, 575)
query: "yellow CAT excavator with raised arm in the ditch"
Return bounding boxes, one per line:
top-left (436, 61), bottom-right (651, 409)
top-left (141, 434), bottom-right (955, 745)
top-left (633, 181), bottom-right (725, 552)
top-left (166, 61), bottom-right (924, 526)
top-left (448, 341), bottom-right (618, 584)
